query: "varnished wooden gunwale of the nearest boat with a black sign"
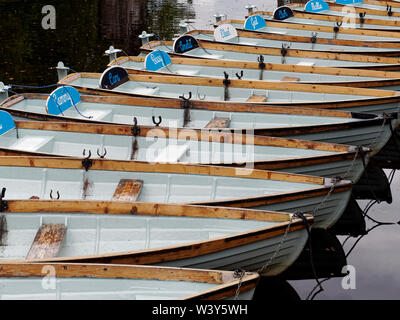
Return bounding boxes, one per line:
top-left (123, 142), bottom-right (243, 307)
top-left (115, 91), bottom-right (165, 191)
top-left (59, 72), bottom-right (400, 99)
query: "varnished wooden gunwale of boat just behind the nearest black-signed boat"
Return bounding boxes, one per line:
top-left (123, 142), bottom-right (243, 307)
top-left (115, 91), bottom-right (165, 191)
top-left (108, 56), bottom-right (400, 79)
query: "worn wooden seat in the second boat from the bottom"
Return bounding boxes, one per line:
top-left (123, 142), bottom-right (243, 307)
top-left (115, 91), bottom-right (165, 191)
top-left (26, 224), bottom-right (67, 260)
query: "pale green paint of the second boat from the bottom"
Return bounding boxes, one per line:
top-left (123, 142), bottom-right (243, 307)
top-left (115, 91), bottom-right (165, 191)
top-left (0, 214), bottom-right (308, 281)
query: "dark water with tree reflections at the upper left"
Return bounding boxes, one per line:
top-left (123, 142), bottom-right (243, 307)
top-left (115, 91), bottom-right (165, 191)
top-left (0, 0), bottom-right (195, 86)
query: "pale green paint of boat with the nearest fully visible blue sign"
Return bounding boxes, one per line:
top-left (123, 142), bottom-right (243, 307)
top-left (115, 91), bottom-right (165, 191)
top-left (4, 99), bottom-right (397, 155)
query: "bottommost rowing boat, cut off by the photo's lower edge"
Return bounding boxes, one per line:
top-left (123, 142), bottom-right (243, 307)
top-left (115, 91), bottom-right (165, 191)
top-left (0, 263), bottom-right (259, 300)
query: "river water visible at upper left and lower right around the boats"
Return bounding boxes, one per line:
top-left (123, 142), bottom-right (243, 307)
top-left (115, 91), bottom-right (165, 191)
top-left (0, 0), bottom-right (400, 300)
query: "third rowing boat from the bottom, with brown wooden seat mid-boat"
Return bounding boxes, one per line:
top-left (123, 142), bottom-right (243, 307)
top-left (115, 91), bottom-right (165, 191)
top-left (0, 157), bottom-right (352, 228)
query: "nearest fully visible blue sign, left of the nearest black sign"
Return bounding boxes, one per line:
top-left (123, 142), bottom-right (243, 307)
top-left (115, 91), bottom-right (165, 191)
top-left (46, 86), bottom-right (81, 116)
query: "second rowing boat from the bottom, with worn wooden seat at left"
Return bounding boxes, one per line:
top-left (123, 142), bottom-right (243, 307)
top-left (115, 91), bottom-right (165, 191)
top-left (0, 200), bottom-right (313, 276)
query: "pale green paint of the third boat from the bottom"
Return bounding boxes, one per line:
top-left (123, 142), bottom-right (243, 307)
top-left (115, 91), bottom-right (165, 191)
top-left (0, 166), bottom-right (351, 228)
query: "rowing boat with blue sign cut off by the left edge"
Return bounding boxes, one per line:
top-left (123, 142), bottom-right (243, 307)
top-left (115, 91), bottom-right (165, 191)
top-left (0, 111), bottom-right (369, 182)
